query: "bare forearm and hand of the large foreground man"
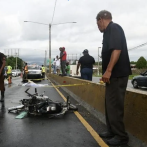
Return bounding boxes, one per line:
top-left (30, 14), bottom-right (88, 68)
top-left (102, 50), bottom-right (121, 83)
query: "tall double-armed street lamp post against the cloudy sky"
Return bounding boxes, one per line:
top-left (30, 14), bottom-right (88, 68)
top-left (24, 21), bottom-right (76, 73)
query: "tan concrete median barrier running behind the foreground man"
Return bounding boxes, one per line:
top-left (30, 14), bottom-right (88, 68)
top-left (49, 74), bottom-right (147, 143)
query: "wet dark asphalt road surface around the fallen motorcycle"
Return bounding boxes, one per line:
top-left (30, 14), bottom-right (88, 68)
top-left (0, 77), bottom-right (133, 147)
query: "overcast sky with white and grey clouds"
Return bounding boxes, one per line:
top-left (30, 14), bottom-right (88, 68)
top-left (0, 0), bottom-right (147, 63)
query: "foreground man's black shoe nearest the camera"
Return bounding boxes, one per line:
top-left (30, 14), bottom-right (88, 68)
top-left (107, 136), bottom-right (129, 146)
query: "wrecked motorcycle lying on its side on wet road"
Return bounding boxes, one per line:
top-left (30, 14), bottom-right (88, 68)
top-left (8, 88), bottom-right (78, 117)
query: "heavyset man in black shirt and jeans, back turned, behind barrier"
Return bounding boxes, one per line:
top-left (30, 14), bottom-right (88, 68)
top-left (76, 49), bottom-right (95, 81)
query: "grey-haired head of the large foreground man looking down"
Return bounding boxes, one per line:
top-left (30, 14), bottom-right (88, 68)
top-left (96, 10), bottom-right (112, 32)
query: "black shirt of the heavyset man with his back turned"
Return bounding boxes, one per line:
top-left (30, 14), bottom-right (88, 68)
top-left (78, 54), bottom-right (95, 69)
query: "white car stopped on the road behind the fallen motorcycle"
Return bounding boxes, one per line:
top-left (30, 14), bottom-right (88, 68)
top-left (23, 65), bottom-right (42, 81)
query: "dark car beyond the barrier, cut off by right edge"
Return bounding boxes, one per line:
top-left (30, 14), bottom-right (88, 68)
top-left (131, 71), bottom-right (147, 88)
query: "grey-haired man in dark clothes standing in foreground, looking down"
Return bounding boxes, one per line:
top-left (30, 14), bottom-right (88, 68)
top-left (96, 10), bottom-right (131, 146)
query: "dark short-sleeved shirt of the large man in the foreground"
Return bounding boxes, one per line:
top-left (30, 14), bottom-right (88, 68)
top-left (102, 22), bottom-right (132, 78)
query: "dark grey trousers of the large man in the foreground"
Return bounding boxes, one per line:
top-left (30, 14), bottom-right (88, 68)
top-left (105, 77), bottom-right (128, 138)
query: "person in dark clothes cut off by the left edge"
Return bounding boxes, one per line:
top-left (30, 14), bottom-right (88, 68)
top-left (0, 53), bottom-right (6, 104)
